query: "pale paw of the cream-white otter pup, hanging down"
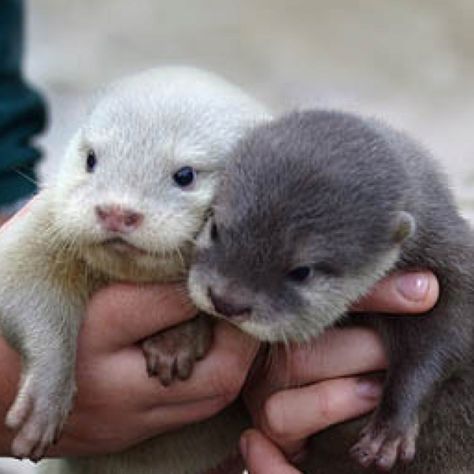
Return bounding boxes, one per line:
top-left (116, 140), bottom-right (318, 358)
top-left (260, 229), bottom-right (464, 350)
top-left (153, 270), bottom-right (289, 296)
top-left (5, 376), bottom-right (73, 462)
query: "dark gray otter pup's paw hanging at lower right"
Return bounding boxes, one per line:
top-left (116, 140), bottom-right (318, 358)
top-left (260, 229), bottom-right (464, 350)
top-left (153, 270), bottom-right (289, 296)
top-left (350, 417), bottom-right (418, 471)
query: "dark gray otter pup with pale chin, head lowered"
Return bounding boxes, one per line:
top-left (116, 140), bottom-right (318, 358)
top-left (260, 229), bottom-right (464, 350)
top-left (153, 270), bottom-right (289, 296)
top-left (189, 111), bottom-right (474, 474)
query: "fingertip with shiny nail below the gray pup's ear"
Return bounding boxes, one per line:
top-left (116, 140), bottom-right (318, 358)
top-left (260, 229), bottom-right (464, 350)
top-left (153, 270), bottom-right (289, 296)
top-left (353, 271), bottom-right (439, 314)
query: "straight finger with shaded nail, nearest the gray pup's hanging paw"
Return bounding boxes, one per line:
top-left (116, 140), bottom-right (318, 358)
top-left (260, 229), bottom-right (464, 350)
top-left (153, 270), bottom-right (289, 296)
top-left (260, 376), bottom-right (382, 454)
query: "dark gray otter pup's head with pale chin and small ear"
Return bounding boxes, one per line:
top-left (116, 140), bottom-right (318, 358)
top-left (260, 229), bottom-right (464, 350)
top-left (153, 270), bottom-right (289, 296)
top-left (189, 112), bottom-right (414, 341)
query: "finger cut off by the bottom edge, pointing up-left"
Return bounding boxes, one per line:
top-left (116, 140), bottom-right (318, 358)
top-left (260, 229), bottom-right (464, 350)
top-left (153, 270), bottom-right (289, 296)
top-left (240, 430), bottom-right (300, 474)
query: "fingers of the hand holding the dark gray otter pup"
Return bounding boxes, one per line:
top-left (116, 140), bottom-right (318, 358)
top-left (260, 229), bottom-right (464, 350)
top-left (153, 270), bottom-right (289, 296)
top-left (240, 271), bottom-right (439, 474)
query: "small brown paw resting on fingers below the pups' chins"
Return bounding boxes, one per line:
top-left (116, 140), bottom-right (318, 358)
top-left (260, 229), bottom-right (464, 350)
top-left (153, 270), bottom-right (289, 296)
top-left (142, 315), bottom-right (213, 387)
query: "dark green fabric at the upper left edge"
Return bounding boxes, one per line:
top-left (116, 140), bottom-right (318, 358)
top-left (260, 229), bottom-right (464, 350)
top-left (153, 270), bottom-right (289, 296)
top-left (0, 0), bottom-right (46, 206)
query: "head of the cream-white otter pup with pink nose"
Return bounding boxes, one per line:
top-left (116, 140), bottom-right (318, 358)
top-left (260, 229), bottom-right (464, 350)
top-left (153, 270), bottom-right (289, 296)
top-left (53, 67), bottom-right (268, 279)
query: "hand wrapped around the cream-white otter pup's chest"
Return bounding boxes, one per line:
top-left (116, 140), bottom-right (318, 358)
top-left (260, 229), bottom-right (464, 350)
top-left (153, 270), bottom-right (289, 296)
top-left (0, 284), bottom-right (258, 456)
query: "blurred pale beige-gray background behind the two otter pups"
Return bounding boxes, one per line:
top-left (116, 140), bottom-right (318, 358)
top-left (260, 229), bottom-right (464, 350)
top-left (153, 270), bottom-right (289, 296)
top-left (0, 0), bottom-right (474, 474)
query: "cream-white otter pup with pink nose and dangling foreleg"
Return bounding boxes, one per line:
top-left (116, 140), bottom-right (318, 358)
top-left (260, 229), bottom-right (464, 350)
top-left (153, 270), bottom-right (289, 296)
top-left (0, 68), bottom-right (267, 473)
